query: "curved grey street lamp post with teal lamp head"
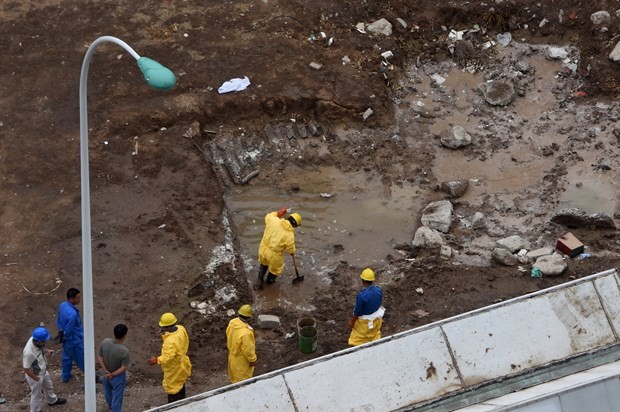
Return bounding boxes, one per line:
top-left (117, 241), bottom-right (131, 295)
top-left (80, 36), bottom-right (176, 412)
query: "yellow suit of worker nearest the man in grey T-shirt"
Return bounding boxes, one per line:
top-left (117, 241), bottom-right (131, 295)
top-left (157, 325), bottom-right (192, 395)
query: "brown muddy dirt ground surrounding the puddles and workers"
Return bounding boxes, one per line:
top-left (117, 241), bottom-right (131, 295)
top-left (0, 0), bottom-right (620, 411)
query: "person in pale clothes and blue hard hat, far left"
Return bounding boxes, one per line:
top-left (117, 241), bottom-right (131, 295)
top-left (22, 327), bottom-right (67, 412)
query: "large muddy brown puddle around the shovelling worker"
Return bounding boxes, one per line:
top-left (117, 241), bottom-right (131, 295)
top-left (225, 167), bottom-right (422, 310)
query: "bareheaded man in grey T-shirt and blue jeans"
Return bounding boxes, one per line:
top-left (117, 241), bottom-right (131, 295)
top-left (98, 323), bottom-right (129, 412)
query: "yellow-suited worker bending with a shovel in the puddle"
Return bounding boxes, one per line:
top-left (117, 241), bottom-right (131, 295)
top-left (258, 207), bottom-right (301, 289)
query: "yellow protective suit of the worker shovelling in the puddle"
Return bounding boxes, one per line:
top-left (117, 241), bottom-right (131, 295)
top-left (258, 212), bottom-right (295, 276)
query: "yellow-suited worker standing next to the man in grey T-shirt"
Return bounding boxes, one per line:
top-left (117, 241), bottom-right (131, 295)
top-left (148, 312), bottom-right (192, 403)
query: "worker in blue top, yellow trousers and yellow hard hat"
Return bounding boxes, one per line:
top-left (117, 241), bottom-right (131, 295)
top-left (349, 268), bottom-right (385, 346)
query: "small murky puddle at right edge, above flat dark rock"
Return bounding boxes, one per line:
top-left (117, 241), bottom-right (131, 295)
top-left (560, 167), bottom-right (618, 216)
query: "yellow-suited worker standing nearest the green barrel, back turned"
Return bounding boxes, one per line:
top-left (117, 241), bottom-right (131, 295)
top-left (226, 305), bottom-right (256, 383)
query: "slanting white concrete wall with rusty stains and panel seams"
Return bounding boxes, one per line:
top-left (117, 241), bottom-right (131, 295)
top-left (153, 270), bottom-right (620, 412)
